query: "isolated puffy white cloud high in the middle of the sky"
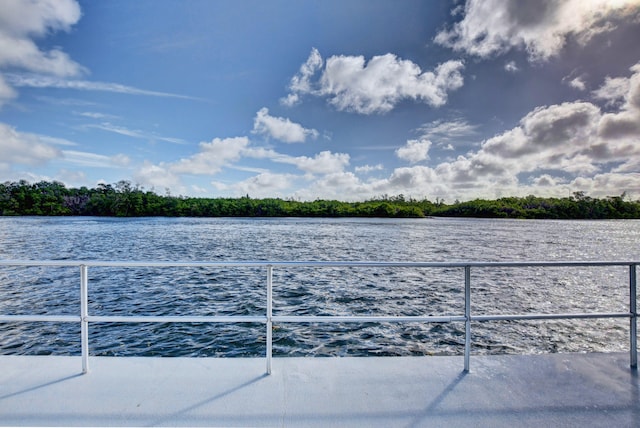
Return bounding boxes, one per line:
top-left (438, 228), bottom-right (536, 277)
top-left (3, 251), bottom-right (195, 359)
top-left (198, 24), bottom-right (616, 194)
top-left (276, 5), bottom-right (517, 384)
top-left (283, 49), bottom-right (464, 114)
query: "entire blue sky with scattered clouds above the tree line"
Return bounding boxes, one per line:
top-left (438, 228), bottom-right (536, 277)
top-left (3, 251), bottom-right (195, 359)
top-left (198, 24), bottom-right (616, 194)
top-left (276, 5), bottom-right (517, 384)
top-left (0, 0), bottom-right (640, 203)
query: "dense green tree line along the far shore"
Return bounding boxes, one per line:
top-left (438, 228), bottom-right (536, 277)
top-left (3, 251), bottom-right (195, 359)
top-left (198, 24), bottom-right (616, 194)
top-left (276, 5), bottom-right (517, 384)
top-left (0, 180), bottom-right (640, 219)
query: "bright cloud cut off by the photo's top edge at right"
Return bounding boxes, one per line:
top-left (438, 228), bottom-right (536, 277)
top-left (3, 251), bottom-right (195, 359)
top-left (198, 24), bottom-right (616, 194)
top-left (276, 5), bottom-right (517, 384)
top-left (435, 0), bottom-right (640, 61)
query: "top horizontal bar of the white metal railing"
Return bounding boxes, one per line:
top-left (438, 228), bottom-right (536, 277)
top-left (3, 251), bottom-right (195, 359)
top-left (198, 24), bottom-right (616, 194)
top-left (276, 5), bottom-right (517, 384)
top-left (0, 260), bottom-right (640, 268)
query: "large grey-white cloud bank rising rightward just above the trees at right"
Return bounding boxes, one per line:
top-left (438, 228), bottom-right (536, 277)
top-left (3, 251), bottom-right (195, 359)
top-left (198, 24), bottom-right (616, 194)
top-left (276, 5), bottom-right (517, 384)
top-left (299, 65), bottom-right (640, 201)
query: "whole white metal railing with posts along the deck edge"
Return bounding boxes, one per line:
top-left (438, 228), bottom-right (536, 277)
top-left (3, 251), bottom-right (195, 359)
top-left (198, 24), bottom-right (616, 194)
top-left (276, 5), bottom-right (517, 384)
top-left (0, 260), bottom-right (640, 374)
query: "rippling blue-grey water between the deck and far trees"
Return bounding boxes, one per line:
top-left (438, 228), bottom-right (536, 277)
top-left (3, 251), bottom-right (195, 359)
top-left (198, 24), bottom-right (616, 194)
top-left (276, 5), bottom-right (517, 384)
top-left (0, 217), bottom-right (640, 357)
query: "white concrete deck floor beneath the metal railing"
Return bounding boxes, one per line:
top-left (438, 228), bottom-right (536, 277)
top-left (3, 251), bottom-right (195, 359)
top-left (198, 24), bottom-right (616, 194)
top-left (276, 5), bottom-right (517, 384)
top-left (0, 353), bottom-right (640, 427)
